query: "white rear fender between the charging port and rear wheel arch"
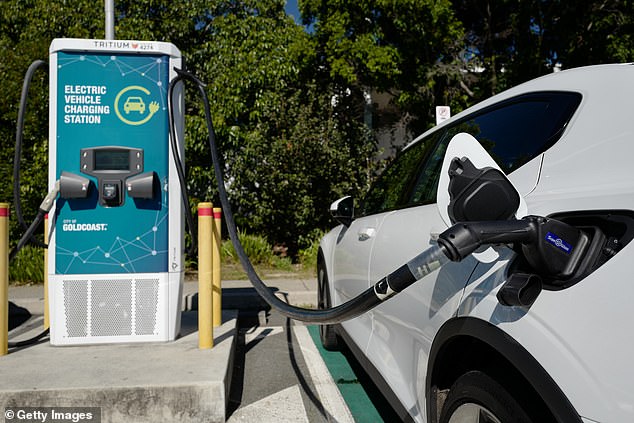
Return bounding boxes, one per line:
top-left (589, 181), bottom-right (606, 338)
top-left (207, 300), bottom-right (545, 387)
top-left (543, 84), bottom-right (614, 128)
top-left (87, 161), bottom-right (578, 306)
top-left (458, 245), bottom-right (634, 422)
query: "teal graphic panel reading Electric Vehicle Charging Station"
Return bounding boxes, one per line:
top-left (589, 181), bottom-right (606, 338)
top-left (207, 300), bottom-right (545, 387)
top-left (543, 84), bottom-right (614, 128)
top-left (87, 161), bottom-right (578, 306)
top-left (54, 52), bottom-right (169, 274)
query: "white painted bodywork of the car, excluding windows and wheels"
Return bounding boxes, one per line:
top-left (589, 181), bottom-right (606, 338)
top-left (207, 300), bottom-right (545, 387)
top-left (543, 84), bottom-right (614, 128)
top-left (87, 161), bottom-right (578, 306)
top-left (321, 64), bottom-right (634, 422)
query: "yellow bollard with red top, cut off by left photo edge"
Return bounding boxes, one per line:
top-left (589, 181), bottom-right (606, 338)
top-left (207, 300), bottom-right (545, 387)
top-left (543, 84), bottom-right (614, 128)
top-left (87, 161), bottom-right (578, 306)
top-left (0, 203), bottom-right (9, 356)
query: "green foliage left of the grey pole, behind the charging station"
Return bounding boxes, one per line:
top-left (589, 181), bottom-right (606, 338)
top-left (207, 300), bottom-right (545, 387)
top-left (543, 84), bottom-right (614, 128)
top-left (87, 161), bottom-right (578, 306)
top-left (0, 0), bottom-right (103, 242)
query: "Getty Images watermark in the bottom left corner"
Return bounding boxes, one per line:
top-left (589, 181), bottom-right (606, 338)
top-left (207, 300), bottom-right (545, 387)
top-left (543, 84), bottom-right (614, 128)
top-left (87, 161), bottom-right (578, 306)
top-left (4, 407), bottom-right (101, 423)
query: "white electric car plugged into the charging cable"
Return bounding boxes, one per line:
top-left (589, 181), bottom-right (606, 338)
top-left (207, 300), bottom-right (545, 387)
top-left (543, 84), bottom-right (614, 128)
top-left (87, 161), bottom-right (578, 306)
top-left (318, 64), bottom-right (634, 423)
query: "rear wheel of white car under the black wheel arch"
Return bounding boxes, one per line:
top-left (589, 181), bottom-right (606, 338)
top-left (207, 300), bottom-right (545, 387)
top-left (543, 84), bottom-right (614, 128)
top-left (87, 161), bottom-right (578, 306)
top-left (440, 371), bottom-right (532, 423)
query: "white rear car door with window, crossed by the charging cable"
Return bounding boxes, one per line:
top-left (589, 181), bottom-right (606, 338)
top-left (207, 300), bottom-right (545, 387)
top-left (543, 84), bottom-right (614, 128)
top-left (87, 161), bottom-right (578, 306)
top-left (366, 131), bottom-right (476, 420)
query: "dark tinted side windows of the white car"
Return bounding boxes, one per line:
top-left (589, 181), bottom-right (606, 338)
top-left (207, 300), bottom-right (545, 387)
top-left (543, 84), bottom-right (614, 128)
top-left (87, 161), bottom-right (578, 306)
top-left (361, 91), bottom-right (581, 216)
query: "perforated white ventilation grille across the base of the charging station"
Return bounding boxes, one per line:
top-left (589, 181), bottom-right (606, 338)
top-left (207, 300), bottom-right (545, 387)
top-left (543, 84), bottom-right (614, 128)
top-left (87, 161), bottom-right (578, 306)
top-left (62, 278), bottom-right (159, 338)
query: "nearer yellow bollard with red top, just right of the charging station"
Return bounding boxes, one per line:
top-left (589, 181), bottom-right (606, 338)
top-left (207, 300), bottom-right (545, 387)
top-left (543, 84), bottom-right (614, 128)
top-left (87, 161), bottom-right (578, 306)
top-left (198, 203), bottom-right (214, 350)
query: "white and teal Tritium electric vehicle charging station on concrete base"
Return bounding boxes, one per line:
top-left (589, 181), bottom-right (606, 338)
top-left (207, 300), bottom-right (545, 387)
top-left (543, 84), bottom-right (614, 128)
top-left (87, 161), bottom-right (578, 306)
top-left (48, 39), bottom-right (184, 345)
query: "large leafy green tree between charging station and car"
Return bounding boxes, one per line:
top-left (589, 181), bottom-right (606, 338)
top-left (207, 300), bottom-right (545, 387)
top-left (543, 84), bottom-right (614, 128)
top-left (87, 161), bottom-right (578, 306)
top-left (188, 2), bottom-right (374, 253)
